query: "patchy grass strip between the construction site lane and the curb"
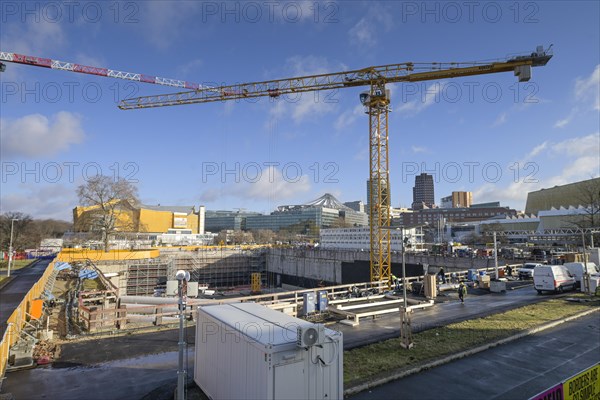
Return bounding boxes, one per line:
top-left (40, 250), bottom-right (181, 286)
top-left (344, 294), bottom-right (600, 387)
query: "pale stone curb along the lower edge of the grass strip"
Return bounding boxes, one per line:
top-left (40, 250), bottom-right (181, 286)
top-left (344, 308), bottom-right (600, 396)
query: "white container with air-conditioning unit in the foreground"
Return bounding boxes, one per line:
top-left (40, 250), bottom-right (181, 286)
top-left (194, 303), bottom-right (344, 400)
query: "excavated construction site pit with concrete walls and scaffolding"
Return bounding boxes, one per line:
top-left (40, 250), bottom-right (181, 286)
top-left (8, 242), bottom-right (596, 352)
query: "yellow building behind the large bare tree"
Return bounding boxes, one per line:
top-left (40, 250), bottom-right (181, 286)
top-left (73, 200), bottom-right (205, 234)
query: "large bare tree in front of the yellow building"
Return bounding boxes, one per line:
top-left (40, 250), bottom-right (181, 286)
top-left (75, 175), bottom-right (139, 251)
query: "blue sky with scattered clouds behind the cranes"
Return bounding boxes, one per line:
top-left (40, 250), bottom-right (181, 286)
top-left (0, 1), bottom-right (600, 220)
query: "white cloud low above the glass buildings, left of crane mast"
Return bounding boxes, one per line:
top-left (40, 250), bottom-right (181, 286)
top-left (201, 164), bottom-right (311, 202)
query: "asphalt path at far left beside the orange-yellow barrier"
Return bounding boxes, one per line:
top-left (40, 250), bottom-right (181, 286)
top-left (0, 260), bottom-right (52, 338)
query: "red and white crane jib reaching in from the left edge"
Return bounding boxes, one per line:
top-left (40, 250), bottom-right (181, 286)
top-left (0, 51), bottom-right (216, 91)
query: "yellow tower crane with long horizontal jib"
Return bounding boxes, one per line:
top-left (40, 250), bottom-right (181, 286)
top-left (119, 46), bottom-right (552, 285)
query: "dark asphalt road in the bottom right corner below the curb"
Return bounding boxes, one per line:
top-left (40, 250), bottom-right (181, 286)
top-left (351, 313), bottom-right (600, 400)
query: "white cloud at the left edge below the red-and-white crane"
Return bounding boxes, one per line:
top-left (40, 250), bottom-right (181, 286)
top-left (0, 111), bottom-right (85, 158)
